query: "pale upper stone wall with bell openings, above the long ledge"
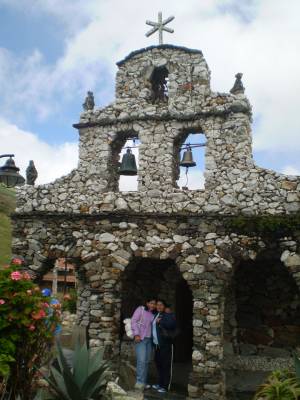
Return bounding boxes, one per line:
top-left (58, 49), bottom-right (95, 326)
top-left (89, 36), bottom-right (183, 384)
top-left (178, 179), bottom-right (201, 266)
top-left (17, 46), bottom-right (300, 215)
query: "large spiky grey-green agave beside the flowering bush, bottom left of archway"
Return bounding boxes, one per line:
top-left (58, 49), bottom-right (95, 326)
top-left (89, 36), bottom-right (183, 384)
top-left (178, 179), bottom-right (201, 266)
top-left (45, 341), bottom-right (109, 400)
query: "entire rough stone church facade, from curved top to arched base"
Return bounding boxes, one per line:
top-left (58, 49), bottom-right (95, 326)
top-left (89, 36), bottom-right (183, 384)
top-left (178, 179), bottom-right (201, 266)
top-left (13, 45), bottom-right (300, 399)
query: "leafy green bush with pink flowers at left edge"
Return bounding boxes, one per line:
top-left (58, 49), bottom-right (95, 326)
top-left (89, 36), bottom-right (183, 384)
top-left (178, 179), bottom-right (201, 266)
top-left (0, 259), bottom-right (59, 400)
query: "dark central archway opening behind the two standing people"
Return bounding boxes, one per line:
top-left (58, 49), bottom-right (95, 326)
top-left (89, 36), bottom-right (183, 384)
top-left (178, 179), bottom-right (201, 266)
top-left (120, 258), bottom-right (193, 392)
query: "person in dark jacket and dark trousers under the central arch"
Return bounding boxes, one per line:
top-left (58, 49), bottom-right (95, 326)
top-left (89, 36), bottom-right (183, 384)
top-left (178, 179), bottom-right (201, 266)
top-left (152, 300), bottom-right (176, 393)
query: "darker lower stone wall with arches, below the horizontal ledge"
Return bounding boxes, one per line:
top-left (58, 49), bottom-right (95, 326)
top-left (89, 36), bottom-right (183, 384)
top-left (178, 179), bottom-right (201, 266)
top-left (14, 214), bottom-right (300, 399)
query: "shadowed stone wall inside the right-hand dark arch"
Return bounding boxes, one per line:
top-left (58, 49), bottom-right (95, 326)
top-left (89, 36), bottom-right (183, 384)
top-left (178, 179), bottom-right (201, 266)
top-left (224, 258), bottom-right (300, 357)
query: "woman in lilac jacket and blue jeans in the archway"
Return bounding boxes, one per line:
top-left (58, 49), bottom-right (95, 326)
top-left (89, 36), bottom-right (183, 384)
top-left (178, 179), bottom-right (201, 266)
top-left (131, 299), bottom-right (156, 390)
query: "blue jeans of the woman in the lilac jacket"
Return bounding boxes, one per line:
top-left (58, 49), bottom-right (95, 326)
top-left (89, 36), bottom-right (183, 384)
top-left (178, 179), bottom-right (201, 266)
top-left (135, 338), bottom-right (152, 385)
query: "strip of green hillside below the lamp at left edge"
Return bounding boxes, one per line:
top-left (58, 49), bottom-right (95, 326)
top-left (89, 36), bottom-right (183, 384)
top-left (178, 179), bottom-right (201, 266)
top-left (0, 186), bottom-right (15, 266)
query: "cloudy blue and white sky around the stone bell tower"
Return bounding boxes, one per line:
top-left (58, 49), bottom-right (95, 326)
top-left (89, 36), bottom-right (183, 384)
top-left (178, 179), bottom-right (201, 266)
top-left (0, 0), bottom-right (300, 188)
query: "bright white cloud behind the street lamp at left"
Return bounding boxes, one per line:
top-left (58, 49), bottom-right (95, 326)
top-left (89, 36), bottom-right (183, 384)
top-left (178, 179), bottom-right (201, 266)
top-left (0, 118), bottom-right (78, 184)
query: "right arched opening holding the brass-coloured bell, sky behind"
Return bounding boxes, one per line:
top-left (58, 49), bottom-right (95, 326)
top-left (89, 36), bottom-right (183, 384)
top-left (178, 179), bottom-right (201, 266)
top-left (173, 130), bottom-right (206, 190)
